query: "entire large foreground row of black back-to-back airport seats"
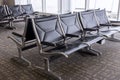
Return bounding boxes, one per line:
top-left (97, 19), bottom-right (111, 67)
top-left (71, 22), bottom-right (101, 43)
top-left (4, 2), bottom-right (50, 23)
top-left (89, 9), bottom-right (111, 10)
top-left (9, 10), bottom-right (120, 80)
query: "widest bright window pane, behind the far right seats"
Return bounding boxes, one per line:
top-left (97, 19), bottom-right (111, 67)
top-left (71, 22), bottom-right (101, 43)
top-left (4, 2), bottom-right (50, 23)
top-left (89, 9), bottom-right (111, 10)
top-left (89, 0), bottom-right (119, 19)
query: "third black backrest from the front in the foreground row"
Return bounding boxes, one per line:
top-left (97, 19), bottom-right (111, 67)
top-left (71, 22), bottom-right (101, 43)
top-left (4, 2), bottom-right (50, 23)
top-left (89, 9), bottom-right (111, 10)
top-left (78, 11), bottom-right (98, 29)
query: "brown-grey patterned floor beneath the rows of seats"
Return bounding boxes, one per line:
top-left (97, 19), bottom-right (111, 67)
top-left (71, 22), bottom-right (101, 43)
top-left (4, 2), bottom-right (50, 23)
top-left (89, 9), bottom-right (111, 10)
top-left (0, 24), bottom-right (120, 80)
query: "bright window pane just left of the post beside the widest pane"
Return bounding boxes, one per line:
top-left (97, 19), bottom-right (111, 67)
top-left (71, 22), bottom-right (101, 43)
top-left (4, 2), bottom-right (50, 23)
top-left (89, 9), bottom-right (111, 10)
top-left (71, 0), bottom-right (85, 11)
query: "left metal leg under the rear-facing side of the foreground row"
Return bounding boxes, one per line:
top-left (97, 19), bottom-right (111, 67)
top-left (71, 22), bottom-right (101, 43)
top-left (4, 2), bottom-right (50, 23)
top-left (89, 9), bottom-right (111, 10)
top-left (11, 48), bottom-right (31, 67)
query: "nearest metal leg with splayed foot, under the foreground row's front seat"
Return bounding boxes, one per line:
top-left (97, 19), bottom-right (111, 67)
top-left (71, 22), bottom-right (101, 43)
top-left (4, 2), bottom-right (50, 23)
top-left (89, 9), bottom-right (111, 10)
top-left (34, 58), bottom-right (62, 80)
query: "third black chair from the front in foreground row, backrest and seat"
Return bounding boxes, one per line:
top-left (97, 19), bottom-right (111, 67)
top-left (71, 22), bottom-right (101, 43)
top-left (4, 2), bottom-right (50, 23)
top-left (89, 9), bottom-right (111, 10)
top-left (78, 11), bottom-right (117, 38)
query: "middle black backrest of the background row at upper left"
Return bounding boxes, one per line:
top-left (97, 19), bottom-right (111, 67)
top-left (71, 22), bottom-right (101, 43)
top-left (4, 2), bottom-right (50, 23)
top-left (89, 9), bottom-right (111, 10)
top-left (8, 5), bottom-right (23, 17)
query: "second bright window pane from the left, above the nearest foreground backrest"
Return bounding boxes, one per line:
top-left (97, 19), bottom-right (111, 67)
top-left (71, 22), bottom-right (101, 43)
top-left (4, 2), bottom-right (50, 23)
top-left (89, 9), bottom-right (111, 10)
top-left (46, 0), bottom-right (58, 13)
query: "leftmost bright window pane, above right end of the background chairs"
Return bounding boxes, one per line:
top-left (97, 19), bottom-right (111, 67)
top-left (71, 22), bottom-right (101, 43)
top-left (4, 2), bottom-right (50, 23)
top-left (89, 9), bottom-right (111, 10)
top-left (30, 0), bottom-right (42, 12)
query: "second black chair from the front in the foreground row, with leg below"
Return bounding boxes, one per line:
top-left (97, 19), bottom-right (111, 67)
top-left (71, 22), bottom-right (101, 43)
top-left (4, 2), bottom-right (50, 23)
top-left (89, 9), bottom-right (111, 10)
top-left (59, 13), bottom-right (103, 55)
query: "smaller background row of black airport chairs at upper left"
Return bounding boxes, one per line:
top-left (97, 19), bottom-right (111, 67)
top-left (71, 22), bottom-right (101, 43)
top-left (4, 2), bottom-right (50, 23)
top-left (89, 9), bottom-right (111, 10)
top-left (0, 4), bottom-right (36, 29)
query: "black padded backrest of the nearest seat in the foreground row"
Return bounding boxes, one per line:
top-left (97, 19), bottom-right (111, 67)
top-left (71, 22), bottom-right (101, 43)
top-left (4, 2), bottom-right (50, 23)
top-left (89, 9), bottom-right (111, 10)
top-left (33, 16), bottom-right (63, 44)
